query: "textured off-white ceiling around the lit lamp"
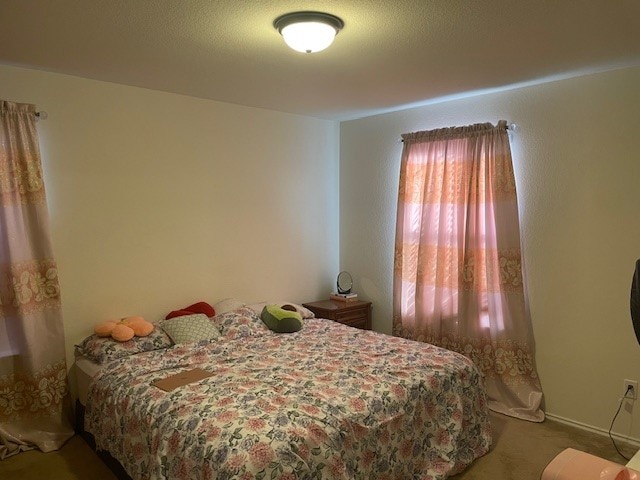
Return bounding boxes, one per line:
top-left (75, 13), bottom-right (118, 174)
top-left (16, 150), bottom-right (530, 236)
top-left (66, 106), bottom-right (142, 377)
top-left (0, 0), bottom-right (640, 120)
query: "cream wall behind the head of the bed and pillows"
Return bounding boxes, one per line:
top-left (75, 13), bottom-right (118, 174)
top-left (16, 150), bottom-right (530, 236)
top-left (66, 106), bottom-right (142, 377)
top-left (0, 66), bottom-right (339, 368)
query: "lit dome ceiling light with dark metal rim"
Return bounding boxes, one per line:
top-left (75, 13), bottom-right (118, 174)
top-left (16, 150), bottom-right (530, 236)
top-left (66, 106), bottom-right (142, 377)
top-left (273, 12), bottom-right (344, 53)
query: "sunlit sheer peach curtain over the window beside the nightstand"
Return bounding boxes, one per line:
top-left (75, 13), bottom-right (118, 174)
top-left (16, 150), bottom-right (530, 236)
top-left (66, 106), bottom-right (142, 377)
top-left (393, 121), bottom-right (544, 421)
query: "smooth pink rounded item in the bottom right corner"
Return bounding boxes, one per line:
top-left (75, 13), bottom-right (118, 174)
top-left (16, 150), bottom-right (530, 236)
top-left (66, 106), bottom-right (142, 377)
top-left (541, 448), bottom-right (640, 480)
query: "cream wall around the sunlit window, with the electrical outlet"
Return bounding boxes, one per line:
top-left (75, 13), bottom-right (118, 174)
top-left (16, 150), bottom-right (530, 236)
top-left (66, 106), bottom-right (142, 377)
top-left (340, 68), bottom-right (640, 439)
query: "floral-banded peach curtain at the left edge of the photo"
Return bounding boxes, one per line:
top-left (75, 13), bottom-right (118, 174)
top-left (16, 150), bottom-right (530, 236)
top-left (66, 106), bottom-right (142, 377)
top-left (0, 101), bottom-right (73, 458)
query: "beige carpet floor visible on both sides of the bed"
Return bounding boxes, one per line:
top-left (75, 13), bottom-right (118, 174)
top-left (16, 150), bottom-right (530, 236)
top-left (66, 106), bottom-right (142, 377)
top-left (0, 414), bottom-right (635, 480)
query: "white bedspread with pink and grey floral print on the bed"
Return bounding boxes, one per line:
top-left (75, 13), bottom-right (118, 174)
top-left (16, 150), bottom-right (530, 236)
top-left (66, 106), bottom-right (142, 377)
top-left (85, 319), bottom-right (491, 480)
